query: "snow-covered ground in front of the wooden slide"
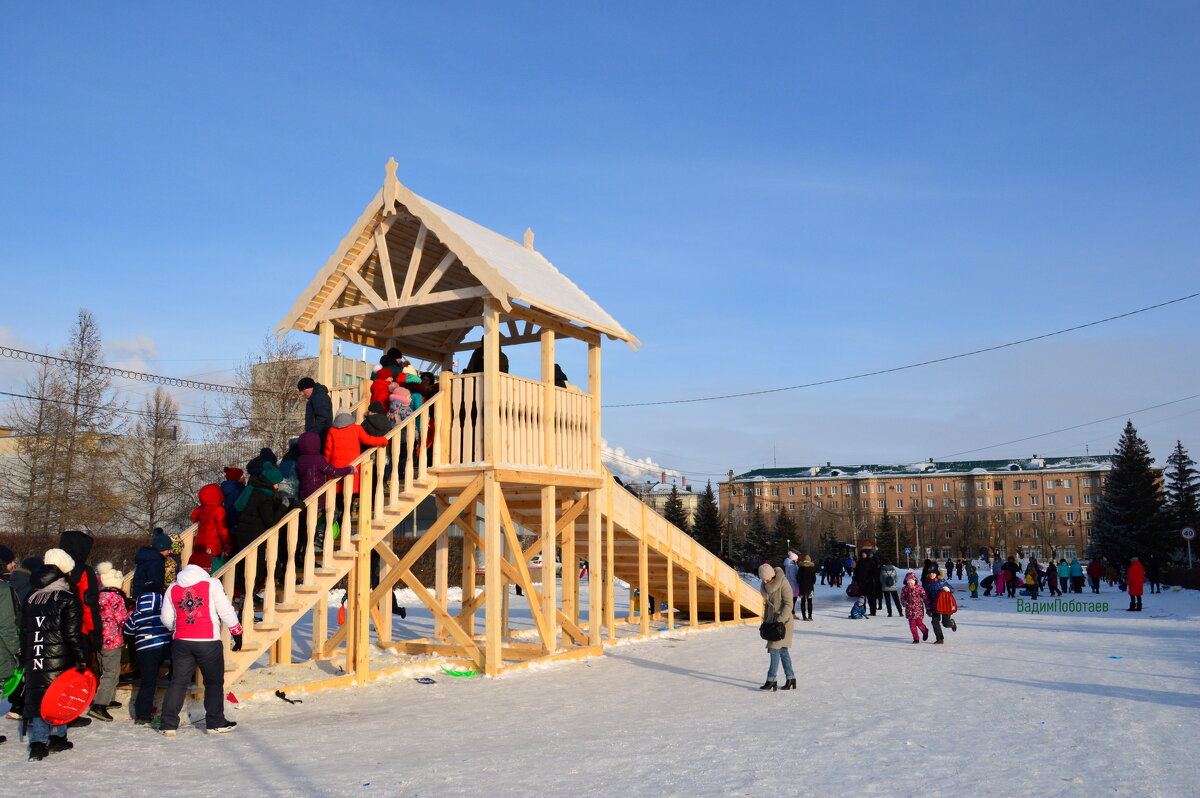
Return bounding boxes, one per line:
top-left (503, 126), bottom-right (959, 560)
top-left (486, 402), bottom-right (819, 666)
top-left (0, 573), bottom-right (1200, 798)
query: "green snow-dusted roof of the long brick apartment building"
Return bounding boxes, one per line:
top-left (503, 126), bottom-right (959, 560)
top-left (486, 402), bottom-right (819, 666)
top-left (733, 455), bottom-right (1112, 482)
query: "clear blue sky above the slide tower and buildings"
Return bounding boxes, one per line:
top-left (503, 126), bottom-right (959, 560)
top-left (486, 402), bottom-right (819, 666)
top-left (0, 2), bottom-right (1200, 481)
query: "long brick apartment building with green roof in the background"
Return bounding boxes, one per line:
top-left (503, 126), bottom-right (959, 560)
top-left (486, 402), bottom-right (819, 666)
top-left (720, 455), bottom-right (1112, 557)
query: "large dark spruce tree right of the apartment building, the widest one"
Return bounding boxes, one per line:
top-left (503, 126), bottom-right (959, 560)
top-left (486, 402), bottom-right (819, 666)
top-left (1087, 421), bottom-right (1166, 564)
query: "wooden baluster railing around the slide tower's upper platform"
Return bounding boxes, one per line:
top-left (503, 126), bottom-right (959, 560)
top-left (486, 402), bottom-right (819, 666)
top-left (434, 374), bottom-right (593, 473)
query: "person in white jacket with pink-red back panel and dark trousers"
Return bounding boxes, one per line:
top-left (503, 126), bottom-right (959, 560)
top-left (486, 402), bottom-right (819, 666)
top-left (158, 557), bottom-right (241, 737)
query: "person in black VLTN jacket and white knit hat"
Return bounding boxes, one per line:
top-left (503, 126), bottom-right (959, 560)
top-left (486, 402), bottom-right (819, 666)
top-left (20, 548), bottom-right (88, 760)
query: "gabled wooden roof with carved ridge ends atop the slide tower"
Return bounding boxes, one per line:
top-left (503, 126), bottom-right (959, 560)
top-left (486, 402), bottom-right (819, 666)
top-left (277, 160), bottom-right (638, 360)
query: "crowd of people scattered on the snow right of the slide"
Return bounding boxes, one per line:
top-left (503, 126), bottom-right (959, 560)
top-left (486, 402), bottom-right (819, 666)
top-left (757, 550), bottom-right (1160, 690)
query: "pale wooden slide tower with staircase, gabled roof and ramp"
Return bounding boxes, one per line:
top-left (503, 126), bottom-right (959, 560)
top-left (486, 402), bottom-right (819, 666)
top-left (154, 161), bottom-right (762, 685)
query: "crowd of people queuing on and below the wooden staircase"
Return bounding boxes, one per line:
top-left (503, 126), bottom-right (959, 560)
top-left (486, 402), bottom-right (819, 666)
top-left (0, 349), bottom-right (448, 761)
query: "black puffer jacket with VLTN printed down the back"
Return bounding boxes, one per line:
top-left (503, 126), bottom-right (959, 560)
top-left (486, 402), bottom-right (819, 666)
top-left (20, 565), bottom-right (88, 718)
